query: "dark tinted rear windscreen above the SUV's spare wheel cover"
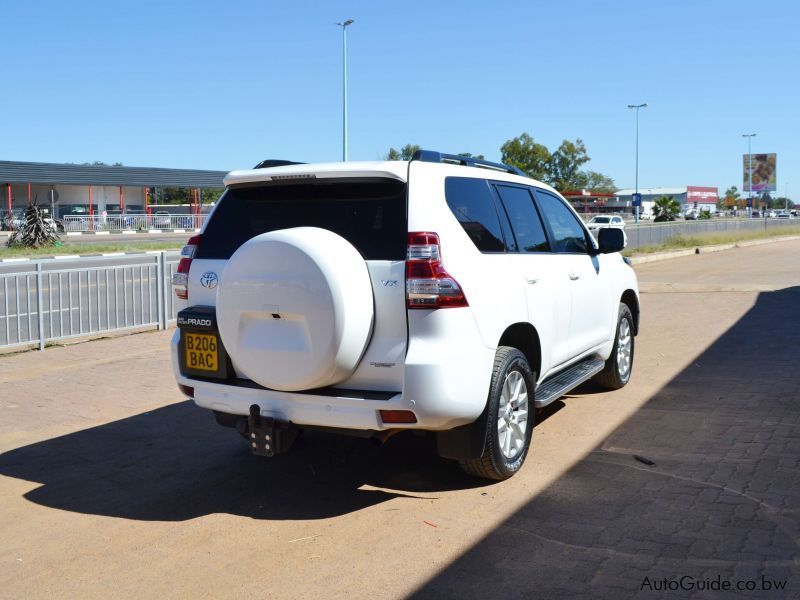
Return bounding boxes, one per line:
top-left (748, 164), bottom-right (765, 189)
top-left (196, 178), bottom-right (407, 260)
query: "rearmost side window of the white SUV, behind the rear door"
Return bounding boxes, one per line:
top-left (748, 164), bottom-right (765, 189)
top-left (444, 177), bottom-right (505, 252)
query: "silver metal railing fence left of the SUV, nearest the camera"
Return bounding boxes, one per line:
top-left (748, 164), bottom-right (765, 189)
top-left (0, 252), bottom-right (180, 350)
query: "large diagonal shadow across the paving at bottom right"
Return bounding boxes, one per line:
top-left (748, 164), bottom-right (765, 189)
top-left (415, 287), bottom-right (800, 598)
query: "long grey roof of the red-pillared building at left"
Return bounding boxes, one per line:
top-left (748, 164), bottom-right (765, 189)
top-left (0, 160), bottom-right (227, 188)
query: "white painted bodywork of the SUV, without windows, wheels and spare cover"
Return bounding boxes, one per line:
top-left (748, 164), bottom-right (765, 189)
top-left (172, 161), bottom-right (638, 430)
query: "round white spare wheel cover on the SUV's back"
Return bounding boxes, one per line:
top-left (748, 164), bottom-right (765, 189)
top-left (217, 227), bottom-right (374, 391)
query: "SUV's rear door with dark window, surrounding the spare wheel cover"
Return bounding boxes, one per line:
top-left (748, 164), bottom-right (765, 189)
top-left (189, 177), bottom-right (408, 390)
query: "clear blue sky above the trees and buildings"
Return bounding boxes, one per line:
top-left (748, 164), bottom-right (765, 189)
top-left (0, 0), bottom-right (800, 198)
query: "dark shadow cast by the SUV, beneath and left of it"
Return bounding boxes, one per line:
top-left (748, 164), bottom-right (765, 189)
top-left (0, 401), bottom-right (488, 521)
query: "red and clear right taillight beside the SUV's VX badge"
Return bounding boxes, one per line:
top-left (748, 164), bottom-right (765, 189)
top-left (406, 231), bottom-right (469, 308)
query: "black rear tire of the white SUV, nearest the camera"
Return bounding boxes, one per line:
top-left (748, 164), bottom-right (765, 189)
top-left (460, 346), bottom-right (536, 481)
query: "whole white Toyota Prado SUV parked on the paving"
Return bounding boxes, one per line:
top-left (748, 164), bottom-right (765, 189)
top-left (172, 151), bottom-right (639, 479)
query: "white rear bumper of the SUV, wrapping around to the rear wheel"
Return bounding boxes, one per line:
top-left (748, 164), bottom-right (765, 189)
top-left (171, 309), bottom-right (495, 431)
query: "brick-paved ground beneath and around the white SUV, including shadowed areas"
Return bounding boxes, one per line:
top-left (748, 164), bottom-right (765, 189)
top-left (0, 241), bottom-right (800, 598)
